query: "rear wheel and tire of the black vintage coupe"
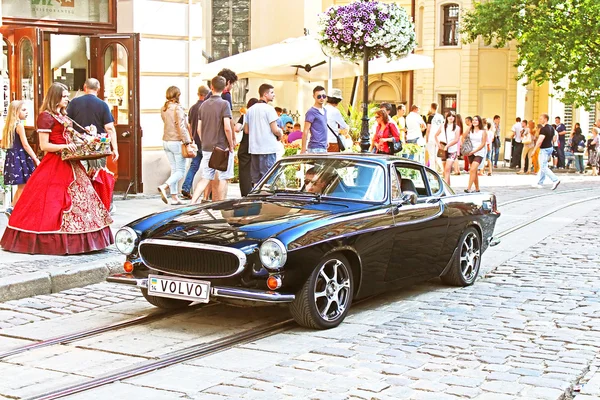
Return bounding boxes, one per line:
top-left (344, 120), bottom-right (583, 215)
top-left (440, 227), bottom-right (481, 286)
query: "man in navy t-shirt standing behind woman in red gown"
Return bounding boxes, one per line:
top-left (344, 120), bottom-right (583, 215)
top-left (67, 78), bottom-right (119, 212)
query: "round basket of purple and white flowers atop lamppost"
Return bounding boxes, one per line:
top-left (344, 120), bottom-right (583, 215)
top-left (318, 0), bottom-right (416, 62)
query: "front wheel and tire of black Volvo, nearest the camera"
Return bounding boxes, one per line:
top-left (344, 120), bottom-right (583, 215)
top-left (290, 253), bottom-right (354, 329)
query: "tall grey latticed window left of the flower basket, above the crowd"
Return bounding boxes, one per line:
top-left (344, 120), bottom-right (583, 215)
top-left (212, 0), bottom-right (250, 60)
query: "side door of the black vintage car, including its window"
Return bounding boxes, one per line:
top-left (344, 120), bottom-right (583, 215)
top-left (385, 162), bottom-right (447, 282)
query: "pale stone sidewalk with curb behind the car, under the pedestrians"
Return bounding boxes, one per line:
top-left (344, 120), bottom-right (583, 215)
top-left (0, 170), bottom-right (600, 302)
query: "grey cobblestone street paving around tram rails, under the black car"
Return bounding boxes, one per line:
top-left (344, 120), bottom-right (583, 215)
top-left (0, 182), bottom-right (600, 400)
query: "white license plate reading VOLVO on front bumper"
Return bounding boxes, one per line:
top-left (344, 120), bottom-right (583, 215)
top-left (148, 275), bottom-right (210, 303)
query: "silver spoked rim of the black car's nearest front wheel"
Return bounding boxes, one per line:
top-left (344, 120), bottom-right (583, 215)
top-left (314, 259), bottom-right (351, 322)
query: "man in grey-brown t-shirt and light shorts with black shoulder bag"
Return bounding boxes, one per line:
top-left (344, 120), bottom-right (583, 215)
top-left (192, 75), bottom-right (234, 204)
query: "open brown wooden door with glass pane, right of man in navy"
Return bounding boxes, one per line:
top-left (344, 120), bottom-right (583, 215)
top-left (90, 33), bottom-right (143, 193)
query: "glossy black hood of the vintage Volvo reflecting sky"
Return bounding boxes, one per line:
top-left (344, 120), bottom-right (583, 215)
top-left (129, 198), bottom-right (366, 248)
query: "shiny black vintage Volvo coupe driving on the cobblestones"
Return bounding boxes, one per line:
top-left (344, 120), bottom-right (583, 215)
top-left (108, 154), bottom-right (500, 329)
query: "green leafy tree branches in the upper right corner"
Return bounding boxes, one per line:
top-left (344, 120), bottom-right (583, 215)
top-left (461, 0), bottom-right (600, 106)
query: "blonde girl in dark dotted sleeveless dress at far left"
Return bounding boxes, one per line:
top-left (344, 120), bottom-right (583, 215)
top-left (2, 100), bottom-right (40, 216)
